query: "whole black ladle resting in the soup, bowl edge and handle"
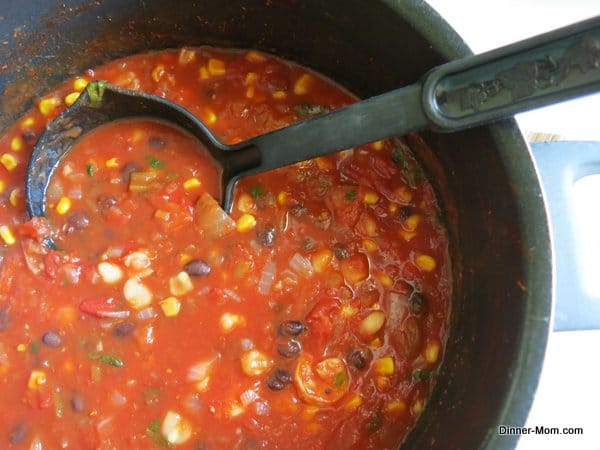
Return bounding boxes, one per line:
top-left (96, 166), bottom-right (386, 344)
top-left (25, 16), bottom-right (600, 217)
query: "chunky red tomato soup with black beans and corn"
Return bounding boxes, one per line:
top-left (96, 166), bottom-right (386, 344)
top-left (0, 48), bottom-right (451, 449)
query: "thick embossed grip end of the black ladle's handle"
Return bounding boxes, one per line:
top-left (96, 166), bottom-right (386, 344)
top-left (422, 16), bottom-right (600, 131)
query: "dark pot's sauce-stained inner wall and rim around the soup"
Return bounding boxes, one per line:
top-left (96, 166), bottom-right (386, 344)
top-left (0, 0), bottom-right (551, 450)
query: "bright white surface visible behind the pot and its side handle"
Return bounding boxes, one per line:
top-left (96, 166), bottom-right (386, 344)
top-left (428, 0), bottom-right (600, 450)
